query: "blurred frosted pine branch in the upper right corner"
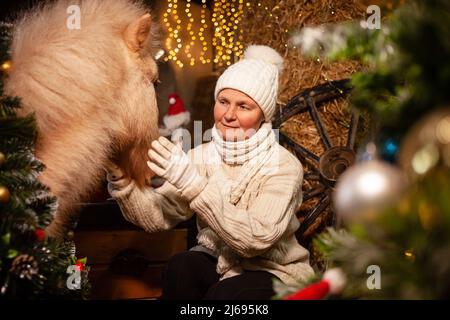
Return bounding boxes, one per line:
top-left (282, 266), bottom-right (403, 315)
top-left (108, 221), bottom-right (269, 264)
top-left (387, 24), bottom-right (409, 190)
top-left (293, 0), bottom-right (450, 138)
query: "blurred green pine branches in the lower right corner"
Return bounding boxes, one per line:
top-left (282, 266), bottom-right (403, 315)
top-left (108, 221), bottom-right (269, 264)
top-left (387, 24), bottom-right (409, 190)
top-left (314, 169), bottom-right (450, 299)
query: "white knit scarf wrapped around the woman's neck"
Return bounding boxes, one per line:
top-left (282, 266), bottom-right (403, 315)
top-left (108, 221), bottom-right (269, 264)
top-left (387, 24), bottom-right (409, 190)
top-left (212, 122), bottom-right (277, 205)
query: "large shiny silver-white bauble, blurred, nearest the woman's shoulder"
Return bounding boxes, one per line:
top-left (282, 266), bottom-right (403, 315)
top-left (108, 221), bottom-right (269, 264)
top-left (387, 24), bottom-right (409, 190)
top-left (333, 160), bottom-right (407, 223)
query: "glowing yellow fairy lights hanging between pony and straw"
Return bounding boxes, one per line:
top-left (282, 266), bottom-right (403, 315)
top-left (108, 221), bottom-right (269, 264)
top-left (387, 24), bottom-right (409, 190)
top-left (163, 0), bottom-right (288, 68)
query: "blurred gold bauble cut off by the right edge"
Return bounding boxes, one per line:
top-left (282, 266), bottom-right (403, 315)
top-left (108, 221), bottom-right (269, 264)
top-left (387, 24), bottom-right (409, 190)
top-left (399, 107), bottom-right (450, 178)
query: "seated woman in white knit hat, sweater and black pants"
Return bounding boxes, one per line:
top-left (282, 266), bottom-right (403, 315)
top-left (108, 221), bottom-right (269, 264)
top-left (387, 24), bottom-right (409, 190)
top-left (108, 46), bottom-right (313, 299)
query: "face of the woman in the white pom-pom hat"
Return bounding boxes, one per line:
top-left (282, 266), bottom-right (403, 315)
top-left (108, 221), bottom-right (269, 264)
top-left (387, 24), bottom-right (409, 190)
top-left (214, 89), bottom-right (264, 141)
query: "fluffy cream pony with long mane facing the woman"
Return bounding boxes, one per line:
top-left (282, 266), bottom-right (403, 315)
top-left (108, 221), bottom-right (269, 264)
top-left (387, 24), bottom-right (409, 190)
top-left (5, 0), bottom-right (159, 237)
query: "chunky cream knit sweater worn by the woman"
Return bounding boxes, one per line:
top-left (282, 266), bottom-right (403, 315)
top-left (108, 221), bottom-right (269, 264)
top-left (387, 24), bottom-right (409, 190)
top-left (109, 142), bottom-right (313, 285)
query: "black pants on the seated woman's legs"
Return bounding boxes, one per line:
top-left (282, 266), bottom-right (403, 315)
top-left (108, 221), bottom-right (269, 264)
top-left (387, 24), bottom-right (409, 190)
top-left (161, 251), bottom-right (275, 300)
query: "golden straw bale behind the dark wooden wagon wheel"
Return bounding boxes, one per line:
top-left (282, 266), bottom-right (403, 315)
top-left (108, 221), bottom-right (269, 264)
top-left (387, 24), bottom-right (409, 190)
top-left (241, 0), bottom-right (366, 156)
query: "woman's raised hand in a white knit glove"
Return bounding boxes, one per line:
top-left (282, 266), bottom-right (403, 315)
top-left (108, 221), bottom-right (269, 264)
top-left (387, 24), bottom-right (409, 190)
top-left (147, 136), bottom-right (207, 201)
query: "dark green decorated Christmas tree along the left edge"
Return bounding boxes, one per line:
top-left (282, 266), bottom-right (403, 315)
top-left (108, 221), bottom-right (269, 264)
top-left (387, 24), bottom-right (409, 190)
top-left (0, 18), bottom-right (90, 299)
